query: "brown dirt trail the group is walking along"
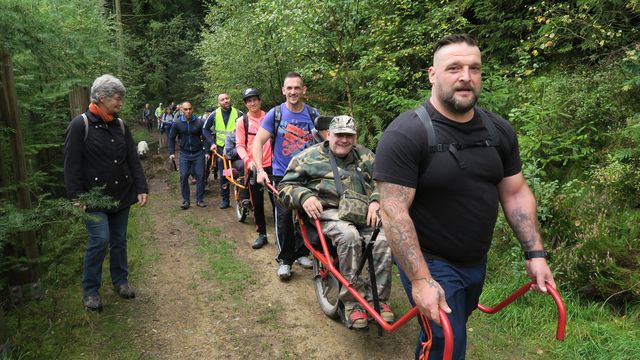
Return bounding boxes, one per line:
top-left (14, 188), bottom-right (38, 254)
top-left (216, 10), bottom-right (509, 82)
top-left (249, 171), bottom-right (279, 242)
top-left (132, 136), bottom-right (417, 359)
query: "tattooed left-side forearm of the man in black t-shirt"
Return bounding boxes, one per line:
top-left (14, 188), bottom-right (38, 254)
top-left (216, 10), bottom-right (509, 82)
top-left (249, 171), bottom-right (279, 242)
top-left (378, 183), bottom-right (424, 274)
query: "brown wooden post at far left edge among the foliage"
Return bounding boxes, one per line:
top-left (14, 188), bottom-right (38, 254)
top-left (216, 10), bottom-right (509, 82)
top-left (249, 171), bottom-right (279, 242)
top-left (0, 50), bottom-right (40, 283)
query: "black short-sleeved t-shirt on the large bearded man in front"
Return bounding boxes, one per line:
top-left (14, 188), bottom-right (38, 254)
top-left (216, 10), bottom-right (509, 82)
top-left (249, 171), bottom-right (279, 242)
top-left (374, 101), bottom-right (522, 265)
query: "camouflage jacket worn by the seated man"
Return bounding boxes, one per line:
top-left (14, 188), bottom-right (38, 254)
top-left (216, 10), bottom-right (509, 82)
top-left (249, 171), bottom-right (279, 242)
top-left (278, 141), bottom-right (379, 209)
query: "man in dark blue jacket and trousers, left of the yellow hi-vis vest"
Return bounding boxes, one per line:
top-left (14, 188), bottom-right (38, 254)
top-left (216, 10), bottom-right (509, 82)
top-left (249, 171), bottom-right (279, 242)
top-left (168, 101), bottom-right (207, 210)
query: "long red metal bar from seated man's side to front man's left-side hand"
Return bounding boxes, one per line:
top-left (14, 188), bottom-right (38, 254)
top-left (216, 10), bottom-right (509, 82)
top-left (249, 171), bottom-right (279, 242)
top-left (298, 216), bottom-right (453, 360)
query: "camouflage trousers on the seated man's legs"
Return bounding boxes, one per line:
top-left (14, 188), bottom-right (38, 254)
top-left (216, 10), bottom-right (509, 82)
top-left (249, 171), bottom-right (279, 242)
top-left (320, 209), bottom-right (392, 309)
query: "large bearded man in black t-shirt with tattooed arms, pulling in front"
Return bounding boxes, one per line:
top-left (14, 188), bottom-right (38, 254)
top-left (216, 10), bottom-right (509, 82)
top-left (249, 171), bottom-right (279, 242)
top-left (374, 35), bottom-right (555, 359)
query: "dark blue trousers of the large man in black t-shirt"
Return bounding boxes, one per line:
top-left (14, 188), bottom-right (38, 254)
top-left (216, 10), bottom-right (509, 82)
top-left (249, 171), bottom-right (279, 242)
top-left (396, 256), bottom-right (487, 359)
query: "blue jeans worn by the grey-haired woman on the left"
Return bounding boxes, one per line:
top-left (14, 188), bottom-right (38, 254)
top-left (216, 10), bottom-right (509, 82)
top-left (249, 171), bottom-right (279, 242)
top-left (82, 207), bottom-right (129, 296)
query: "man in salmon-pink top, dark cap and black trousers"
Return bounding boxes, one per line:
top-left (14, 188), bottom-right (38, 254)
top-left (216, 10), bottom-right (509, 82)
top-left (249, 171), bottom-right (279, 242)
top-left (236, 88), bottom-right (273, 249)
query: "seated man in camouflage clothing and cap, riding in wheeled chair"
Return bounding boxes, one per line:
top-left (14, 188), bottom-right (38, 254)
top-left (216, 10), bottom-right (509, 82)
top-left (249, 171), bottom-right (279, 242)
top-left (278, 115), bottom-right (394, 329)
